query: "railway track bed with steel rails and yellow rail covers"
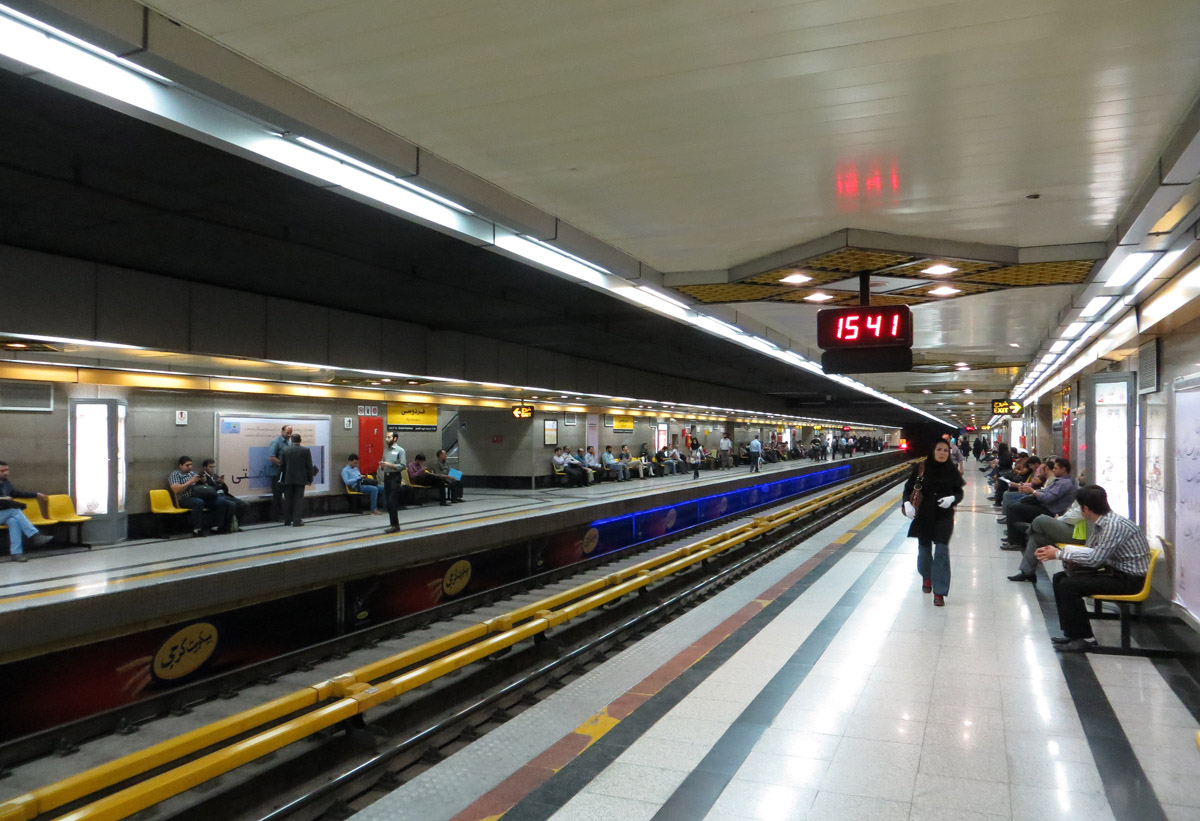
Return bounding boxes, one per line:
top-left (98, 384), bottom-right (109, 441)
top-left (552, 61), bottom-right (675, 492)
top-left (0, 466), bottom-right (906, 821)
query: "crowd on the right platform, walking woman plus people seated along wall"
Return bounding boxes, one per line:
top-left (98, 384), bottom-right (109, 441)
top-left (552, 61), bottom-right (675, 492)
top-left (901, 435), bottom-right (1151, 653)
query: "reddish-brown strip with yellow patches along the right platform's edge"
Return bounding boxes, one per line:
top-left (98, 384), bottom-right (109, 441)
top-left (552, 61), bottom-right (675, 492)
top-left (451, 499), bottom-right (895, 821)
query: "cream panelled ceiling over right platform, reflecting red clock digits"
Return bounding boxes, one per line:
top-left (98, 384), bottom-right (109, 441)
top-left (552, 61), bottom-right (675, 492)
top-left (131, 0), bottom-right (1200, 422)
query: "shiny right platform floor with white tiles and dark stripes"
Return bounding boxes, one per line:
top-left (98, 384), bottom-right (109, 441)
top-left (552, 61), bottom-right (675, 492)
top-left (353, 467), bottom-right (1200, 821)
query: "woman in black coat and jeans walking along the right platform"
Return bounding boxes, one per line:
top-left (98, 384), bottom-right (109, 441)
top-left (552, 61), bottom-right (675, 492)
top-left (901, 439), bottom-right (964, 607)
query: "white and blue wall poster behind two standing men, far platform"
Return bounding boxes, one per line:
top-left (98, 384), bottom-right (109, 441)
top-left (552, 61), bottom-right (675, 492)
top-left (216, 413), bottom-right (330, 496)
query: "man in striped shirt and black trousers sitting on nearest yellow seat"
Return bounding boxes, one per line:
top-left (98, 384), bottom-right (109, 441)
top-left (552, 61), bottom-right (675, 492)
top-left (1036, 485), bottom-right (1150, 653)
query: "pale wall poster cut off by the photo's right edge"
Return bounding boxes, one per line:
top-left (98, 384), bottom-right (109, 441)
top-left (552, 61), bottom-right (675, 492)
top-left (1171, 390), bottom-right (1200, 617)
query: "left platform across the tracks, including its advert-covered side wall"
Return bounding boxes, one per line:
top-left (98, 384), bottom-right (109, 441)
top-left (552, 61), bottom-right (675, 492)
top-left (0, 451), bottom-right (906, 738)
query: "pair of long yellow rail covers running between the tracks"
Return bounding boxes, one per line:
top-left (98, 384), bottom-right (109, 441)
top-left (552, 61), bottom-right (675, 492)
top-left (0, 462), bottom-right (908, 821)
